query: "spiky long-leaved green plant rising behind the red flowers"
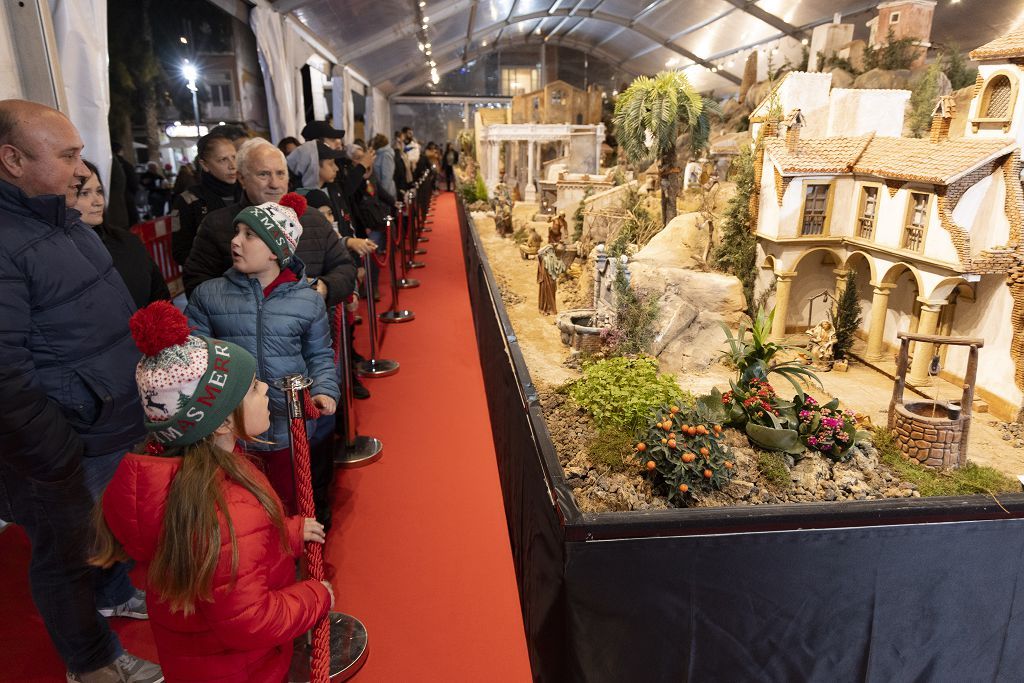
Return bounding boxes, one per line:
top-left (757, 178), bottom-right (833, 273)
top-left (720, 307), bottom-right (824, 398)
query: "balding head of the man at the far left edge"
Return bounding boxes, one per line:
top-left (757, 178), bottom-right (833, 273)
top-left (0, 99), bottom-right (89, 206)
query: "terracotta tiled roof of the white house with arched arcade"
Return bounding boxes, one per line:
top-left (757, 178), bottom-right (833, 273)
top-left (765, 135), bottom-right (1014, 185)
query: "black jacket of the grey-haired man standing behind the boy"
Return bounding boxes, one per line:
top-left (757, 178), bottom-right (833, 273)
top-left (181, 197), bottom-right (355, 307)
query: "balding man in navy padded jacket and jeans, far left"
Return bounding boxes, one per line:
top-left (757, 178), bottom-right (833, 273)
top-left (0, 99), bottom-right (163, 681)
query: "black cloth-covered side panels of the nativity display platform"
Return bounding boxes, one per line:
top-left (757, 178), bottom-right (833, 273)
top-left (457, 193), bottom-right (1024, 683)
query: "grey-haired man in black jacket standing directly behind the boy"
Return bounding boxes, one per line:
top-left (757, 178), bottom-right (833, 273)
top-left (182, 138), bottom-right (355, 307)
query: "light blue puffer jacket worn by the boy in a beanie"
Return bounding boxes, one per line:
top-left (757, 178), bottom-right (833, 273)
top-left (185, 257), bottom-right (341, 451)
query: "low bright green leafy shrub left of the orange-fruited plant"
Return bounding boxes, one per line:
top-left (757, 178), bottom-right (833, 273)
top-left (568, 355), bottom-right (692, 434)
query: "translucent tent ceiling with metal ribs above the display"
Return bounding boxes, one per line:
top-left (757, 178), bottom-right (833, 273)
top-left (271, 0), bottom-right (1024, 93)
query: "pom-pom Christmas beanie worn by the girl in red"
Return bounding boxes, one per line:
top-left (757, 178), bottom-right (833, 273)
top-left (129, 301), bottom-right (256, 446)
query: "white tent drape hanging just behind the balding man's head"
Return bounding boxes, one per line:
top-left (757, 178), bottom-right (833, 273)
top-left (50, 0), bottom-right (112, 186)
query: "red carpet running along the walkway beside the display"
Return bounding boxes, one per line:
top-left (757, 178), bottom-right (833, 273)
top-left (0, 194), bottom-right (530, 683)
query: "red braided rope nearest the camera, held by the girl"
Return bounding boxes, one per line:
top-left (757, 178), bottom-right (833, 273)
top-left (291, 391), bottom-right (331, 683)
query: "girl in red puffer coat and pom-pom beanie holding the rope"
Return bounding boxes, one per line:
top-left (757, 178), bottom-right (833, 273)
top-left (93, 302), bottom-right (334, 683)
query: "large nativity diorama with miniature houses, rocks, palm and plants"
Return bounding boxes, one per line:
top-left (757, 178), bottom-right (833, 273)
top-left (461, 0), bottom-right (1024, 511)
